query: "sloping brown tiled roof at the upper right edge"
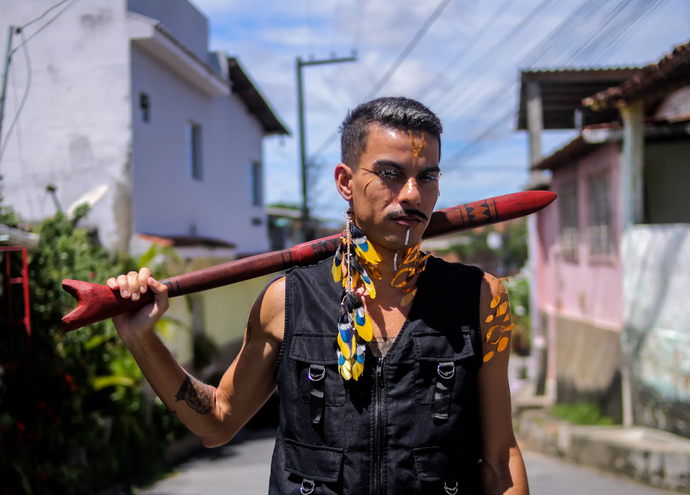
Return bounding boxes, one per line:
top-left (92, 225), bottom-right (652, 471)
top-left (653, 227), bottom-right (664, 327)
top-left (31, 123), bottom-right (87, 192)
top-left (582, 43), bottom-right (690, 111)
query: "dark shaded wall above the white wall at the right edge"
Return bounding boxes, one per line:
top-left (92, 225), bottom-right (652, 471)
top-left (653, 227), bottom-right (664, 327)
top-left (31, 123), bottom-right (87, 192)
top-left (644, 140), bottom-right (690, 224)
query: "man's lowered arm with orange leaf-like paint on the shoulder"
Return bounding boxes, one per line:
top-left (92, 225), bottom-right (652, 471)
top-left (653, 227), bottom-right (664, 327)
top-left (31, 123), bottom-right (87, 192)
top-left (477, 274), bottom-right (529, 495)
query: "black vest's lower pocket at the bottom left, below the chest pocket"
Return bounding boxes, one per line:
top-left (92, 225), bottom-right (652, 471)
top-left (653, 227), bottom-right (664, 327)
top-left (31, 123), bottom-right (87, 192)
top-left (285, 439), bottom-right (343, 495)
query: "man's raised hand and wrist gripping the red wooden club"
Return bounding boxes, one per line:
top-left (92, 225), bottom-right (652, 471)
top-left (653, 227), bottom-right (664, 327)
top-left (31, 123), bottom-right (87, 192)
top-left (107, 267), bottom-right (169, 342)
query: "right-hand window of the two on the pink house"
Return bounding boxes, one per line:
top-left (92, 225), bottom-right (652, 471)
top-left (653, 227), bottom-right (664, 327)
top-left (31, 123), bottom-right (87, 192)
top-left (587, 172), bottom-right (611, 255)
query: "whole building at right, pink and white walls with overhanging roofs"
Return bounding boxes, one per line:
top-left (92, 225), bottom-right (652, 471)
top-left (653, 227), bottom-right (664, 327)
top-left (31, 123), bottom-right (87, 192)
top-left (518, 43), bottom-right (690, 437)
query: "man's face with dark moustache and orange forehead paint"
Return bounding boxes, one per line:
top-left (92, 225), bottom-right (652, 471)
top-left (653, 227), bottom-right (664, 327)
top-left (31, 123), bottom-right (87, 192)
top-left (336, 124), bottom-right (440, 251)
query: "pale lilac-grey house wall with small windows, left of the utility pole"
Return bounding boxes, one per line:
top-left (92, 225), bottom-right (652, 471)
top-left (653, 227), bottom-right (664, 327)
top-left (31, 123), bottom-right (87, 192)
top-left (130, 45), bottom-right (268, 253)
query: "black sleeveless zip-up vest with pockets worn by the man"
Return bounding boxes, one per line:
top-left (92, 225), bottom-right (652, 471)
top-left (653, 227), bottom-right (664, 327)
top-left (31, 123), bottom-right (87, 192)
top-left (269, 257), bottom-right (483, 495)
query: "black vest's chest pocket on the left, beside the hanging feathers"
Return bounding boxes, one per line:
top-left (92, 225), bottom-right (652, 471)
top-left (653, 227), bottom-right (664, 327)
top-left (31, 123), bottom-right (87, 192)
top-left (289, 333), bottom-right (347, 408)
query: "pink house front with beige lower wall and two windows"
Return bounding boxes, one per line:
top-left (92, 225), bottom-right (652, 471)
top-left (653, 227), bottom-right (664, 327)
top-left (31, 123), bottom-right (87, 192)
top-left (535, 126), bottom-right (623, 417)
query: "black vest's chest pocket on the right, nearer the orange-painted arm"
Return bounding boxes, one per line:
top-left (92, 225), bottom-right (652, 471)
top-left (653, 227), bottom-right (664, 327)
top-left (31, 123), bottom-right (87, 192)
top-left (412, 328), bottom-right (474, 408)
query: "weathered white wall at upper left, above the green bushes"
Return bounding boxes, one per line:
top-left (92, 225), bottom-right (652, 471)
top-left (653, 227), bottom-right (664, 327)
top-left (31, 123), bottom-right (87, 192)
top-left (0, 0), bottom-right (131, 250)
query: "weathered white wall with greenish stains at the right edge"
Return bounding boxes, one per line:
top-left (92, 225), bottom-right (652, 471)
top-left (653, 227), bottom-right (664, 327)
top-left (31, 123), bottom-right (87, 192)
top-left (622, 225), bottom-right (690, 437)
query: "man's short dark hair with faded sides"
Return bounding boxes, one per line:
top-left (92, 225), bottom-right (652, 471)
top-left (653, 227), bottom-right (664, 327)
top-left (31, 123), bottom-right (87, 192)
top-left (340, 96), bottom-right (443, 169)
